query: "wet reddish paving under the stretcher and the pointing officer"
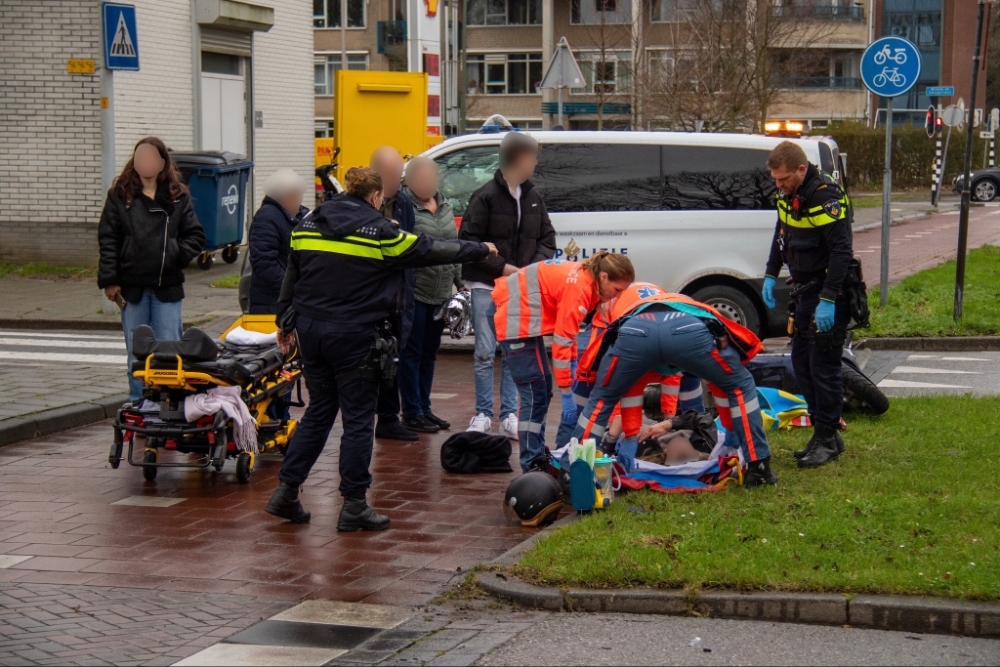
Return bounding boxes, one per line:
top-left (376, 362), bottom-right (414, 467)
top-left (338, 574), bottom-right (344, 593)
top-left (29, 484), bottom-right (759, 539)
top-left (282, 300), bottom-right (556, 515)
top-left (0, 355), bottom-right (558, 604)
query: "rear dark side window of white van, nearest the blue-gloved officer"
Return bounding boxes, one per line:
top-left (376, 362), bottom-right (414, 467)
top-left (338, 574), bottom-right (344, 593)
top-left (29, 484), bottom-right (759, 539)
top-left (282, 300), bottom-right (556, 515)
top-left (662, 146), bottom-right (776, 211)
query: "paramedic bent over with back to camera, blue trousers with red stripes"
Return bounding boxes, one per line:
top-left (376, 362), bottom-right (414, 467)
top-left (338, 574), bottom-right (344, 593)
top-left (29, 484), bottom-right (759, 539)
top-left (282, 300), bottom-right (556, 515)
top-left (573, 287), bottom-right (778, 488)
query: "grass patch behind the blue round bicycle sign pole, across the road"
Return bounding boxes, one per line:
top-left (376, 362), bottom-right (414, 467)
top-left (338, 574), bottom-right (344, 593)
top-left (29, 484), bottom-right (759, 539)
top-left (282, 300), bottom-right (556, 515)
top-left (861, 245), bottom-right (1000, 337)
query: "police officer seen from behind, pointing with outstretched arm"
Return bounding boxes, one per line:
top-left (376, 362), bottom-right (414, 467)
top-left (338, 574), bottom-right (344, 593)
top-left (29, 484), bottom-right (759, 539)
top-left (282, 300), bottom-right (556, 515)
top-left (267, 167), bottom-right (496, 531)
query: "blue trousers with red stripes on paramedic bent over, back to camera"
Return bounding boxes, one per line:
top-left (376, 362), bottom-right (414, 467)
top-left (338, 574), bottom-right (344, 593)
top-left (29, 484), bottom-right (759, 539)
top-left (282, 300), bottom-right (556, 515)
top-left (573, 307), bottom-right (771, 462)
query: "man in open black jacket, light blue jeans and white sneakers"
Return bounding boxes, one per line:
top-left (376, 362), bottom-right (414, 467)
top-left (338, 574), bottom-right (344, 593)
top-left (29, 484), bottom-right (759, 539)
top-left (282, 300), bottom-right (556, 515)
top-left (458, 132), bottom-right (556, 440)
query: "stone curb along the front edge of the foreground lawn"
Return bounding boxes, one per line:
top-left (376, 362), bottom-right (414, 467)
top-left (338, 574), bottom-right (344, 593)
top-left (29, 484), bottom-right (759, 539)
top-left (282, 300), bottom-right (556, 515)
top-left (475, 568), bottom-right (1000, 637)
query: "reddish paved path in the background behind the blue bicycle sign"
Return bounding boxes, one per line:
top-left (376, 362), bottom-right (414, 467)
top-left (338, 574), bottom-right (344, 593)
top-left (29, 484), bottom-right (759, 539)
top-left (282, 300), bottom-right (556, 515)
top-left (854, 206), bottom-right (1000, 288)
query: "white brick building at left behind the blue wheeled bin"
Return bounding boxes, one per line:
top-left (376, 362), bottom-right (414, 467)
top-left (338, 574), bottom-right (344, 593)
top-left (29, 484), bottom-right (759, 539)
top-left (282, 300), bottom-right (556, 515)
top-left (0, 0), bottom-right (313, 266)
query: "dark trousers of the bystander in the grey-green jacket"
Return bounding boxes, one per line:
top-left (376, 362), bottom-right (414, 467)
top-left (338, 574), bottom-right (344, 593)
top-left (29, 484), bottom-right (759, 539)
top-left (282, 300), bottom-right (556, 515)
top-left (398, 301), bottom-right (445, 419)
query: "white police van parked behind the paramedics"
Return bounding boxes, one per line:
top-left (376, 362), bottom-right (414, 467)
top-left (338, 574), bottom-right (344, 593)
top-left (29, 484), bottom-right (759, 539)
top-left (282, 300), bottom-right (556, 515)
top-left (424, 131), bottom-right (842, 337)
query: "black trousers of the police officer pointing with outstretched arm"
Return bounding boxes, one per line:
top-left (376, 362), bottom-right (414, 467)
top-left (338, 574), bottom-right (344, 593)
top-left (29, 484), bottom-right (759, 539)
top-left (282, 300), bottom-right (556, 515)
top-left (278, 315), bottom-right (379, 498)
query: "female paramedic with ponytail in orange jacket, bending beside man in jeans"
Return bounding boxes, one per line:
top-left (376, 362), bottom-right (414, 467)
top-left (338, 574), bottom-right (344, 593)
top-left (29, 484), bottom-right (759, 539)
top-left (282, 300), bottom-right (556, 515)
top-left (493, 251), bottom-right (635, 472)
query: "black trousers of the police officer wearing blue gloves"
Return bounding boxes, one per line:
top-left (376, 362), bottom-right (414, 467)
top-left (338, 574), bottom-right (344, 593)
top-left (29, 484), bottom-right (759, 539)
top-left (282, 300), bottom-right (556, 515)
top-left (792, 290), bottom-right (849, 429)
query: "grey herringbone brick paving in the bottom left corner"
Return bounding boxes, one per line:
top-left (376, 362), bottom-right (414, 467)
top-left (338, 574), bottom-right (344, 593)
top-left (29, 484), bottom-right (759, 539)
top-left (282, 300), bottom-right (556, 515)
top-left (0, 583), bottom-right (289, 665)
